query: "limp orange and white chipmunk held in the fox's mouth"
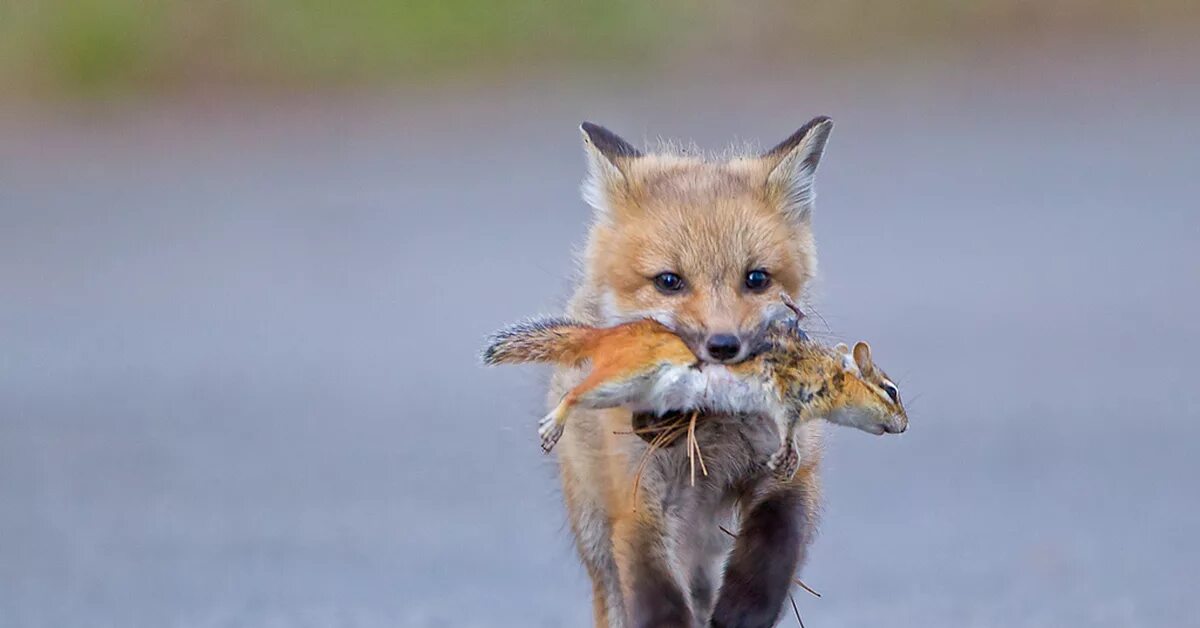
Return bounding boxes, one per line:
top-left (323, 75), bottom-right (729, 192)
top-left (484, 294), bottom-right (908, 479)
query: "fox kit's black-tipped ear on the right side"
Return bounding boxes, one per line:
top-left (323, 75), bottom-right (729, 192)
top-left (761, 115), bottom-right (833, 220)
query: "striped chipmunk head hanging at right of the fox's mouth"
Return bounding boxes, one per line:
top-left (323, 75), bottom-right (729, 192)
top-left (829, 342), bottom-right (908, 435)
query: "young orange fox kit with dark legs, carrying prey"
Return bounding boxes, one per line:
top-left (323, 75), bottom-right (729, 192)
top-left (530, 116), bottom-right (833, 628)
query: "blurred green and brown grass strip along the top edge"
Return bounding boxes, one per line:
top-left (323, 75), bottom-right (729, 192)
top-left (0, 0), bottom-right (1200, 97)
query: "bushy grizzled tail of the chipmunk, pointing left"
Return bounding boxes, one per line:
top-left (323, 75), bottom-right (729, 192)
top-left (484, 318), bottom-right (595, 366)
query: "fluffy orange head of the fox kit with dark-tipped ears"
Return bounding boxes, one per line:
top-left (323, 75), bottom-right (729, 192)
top-left (581, 118), bottom-right (833, 363)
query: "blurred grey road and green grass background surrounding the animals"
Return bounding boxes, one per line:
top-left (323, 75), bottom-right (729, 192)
top-left (0, 0), bottom-right (1200, 628)
